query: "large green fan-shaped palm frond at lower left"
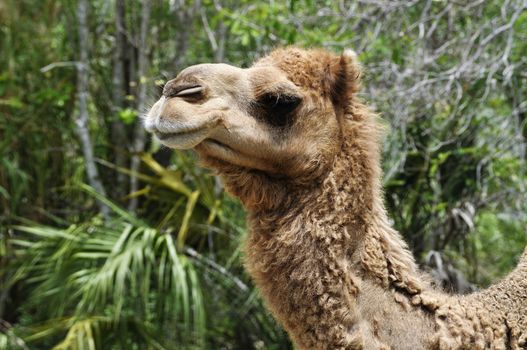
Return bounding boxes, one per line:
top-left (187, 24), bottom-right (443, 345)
top-left (12, 220), bottom-right (205, 349)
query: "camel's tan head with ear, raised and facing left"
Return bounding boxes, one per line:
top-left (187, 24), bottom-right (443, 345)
top-left (145, 48), bottom-right (366, 209)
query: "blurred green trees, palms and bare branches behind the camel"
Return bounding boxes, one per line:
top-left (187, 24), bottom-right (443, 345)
top-left (0, 0), bottom-right (527, 349)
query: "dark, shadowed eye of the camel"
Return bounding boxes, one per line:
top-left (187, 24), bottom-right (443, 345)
top-left (259, 94), bottom-right (302, 127)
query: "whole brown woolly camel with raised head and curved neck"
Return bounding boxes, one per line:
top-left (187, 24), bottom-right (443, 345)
top-left (145, 47), bottom-right (527, 350)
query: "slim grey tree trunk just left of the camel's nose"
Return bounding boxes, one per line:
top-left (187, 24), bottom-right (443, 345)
top-left (128, 0), bottom-right (150, 211)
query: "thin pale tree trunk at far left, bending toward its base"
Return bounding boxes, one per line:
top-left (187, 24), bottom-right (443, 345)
top-left (75, 0), bottom-right (110, 217)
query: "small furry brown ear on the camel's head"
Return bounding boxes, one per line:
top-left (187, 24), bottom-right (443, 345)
top-left (328, 49), bottom-right (361, 105)
